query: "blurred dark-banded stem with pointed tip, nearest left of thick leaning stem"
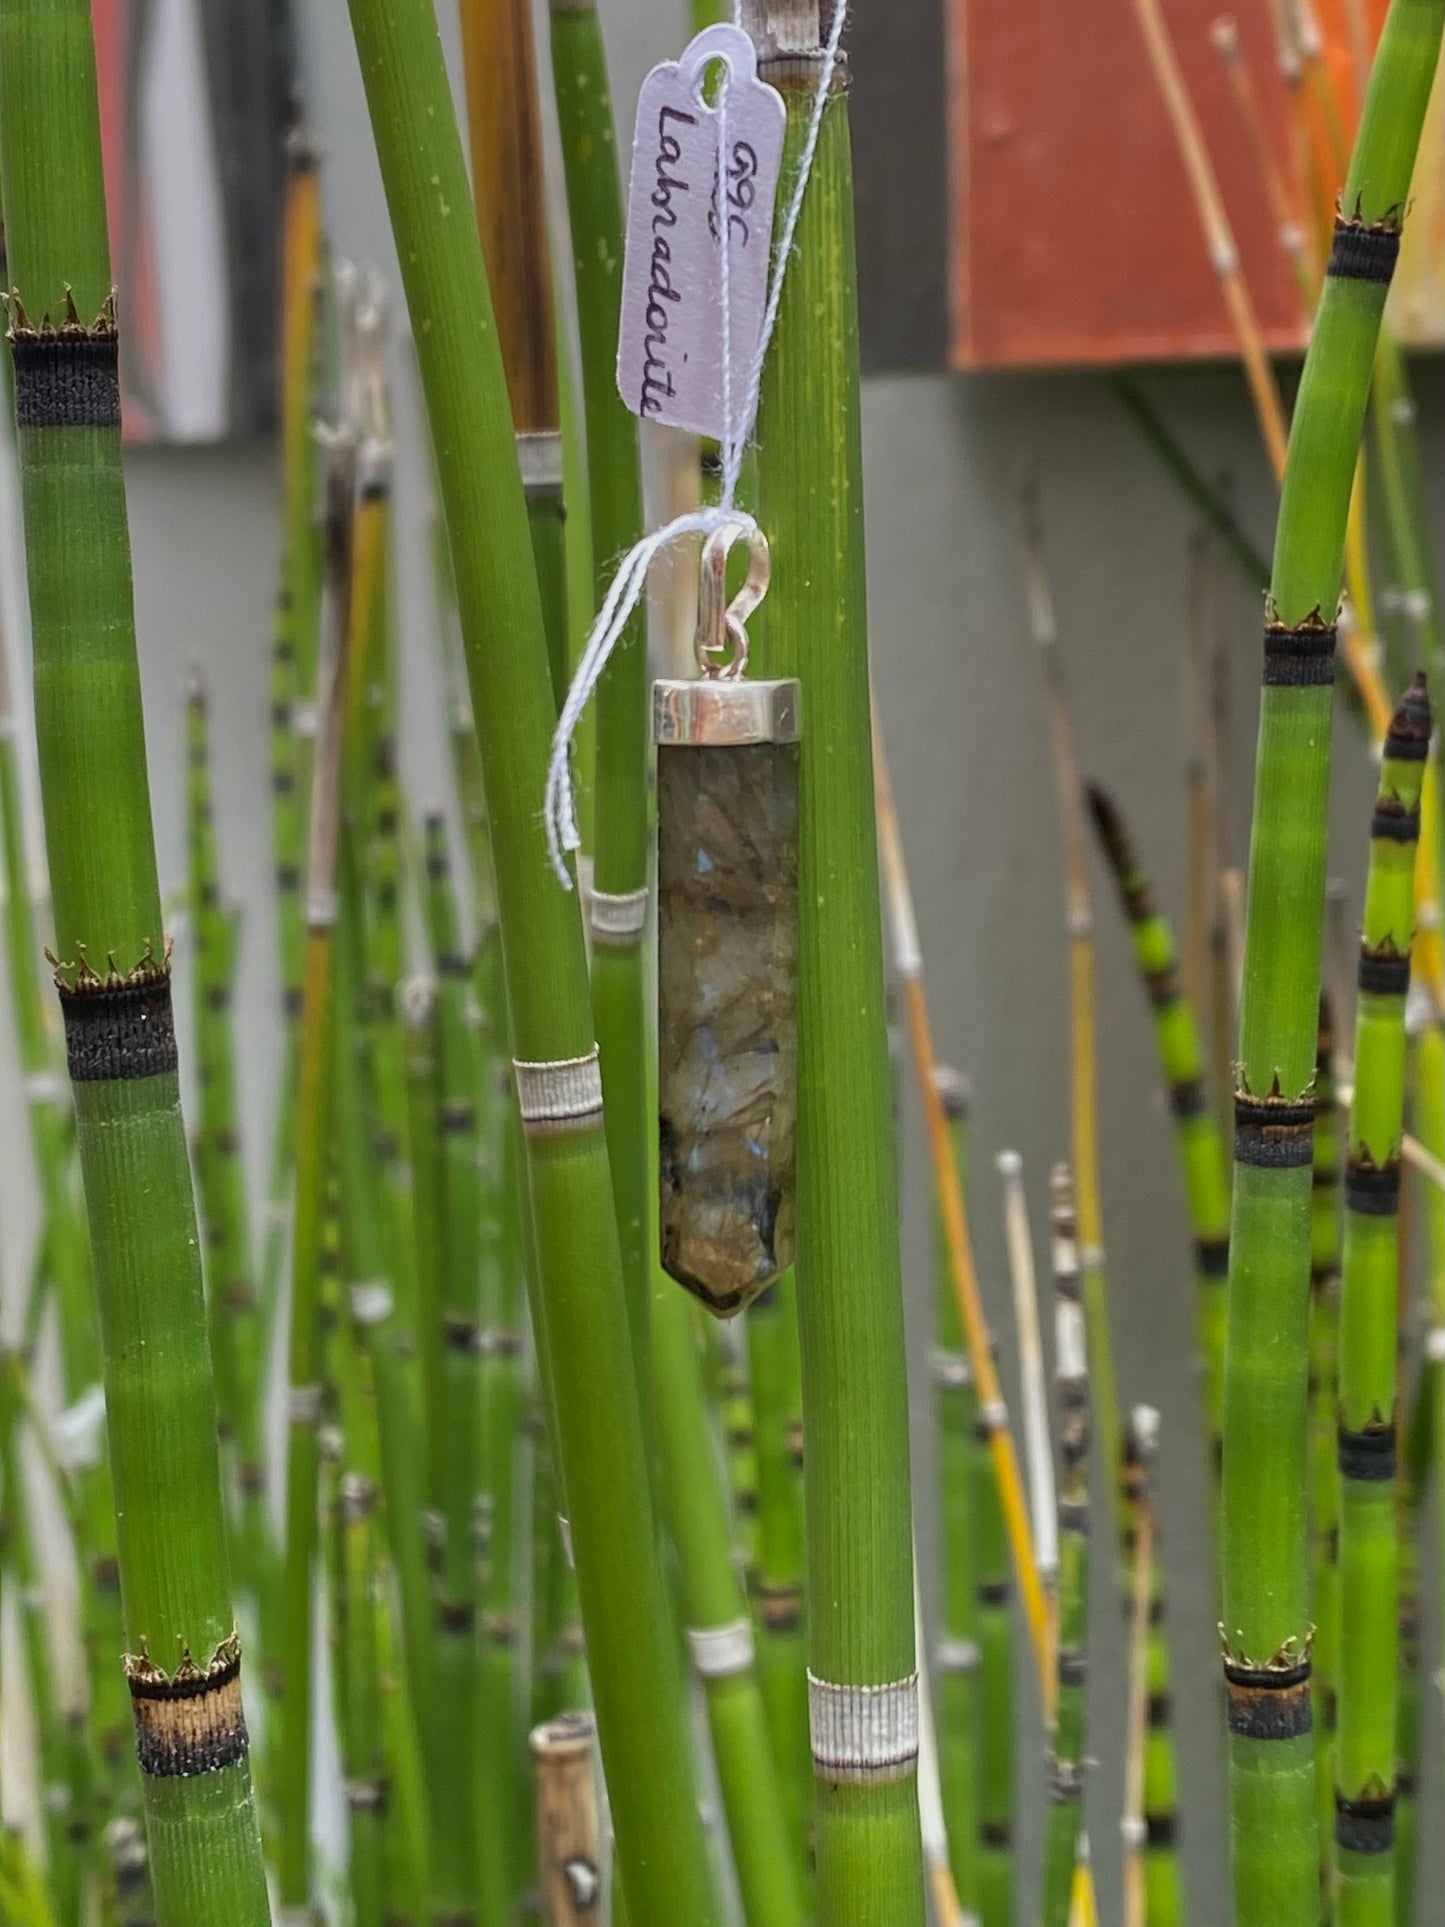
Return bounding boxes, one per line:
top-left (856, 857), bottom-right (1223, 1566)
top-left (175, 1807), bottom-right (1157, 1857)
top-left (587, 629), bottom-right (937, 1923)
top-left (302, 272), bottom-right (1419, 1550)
top-left (424, 815), bottom-right (484, 1927)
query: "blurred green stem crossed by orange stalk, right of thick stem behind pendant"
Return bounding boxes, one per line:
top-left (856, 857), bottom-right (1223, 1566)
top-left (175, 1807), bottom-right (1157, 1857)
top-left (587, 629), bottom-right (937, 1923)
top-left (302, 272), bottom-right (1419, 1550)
top-left (931, 1068), bottom-right (981, 1914)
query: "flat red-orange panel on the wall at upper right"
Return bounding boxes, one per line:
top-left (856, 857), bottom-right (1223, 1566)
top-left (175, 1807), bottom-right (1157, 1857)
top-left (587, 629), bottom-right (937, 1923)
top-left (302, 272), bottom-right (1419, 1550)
top-left (948, 0), bottom-right (1304, 368)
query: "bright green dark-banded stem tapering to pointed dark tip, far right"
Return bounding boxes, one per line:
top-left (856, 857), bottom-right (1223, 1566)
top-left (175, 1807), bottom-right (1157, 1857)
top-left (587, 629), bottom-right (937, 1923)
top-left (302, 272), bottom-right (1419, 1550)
top-left (1335, 671), bottom-right (1430, 1927)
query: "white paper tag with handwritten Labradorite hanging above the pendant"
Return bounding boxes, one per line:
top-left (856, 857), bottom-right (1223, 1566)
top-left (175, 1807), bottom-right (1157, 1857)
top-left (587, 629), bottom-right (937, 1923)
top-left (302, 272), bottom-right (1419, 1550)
top-left (617, 25), bottom-right (788, 439)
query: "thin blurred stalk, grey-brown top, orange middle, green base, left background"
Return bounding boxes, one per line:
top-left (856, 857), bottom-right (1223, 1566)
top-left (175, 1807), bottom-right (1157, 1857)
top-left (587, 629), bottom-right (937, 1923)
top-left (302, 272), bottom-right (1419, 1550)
top-left (276, 428), bottom-right (356, 1908)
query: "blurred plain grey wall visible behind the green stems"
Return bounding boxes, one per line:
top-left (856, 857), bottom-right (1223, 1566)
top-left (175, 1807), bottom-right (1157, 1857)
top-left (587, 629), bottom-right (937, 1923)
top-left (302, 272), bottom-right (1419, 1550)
top-left (0, 0), bottom-right (1445, 1927)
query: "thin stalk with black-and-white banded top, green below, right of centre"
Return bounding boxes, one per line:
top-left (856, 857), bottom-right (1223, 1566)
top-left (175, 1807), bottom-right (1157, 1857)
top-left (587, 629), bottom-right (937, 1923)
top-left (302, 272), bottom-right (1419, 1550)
top-left (1038, 1166), bottom-right (1089, 1927)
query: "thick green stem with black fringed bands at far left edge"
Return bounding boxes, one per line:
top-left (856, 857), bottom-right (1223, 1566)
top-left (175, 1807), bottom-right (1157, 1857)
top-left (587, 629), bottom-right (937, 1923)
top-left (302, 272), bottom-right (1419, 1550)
top-left (0, 0), bottom-right (268, 1927)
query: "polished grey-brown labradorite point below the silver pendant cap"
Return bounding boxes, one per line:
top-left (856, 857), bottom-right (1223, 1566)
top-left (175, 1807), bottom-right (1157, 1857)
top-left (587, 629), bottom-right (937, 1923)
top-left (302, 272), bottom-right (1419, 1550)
top-left (657, 742), bottom-right (798, 1316)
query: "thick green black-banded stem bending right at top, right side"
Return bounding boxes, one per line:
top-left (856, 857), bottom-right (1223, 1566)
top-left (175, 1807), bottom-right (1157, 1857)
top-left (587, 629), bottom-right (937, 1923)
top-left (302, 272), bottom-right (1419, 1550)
top-left (1222, 11), bottom-right (1445, 1927)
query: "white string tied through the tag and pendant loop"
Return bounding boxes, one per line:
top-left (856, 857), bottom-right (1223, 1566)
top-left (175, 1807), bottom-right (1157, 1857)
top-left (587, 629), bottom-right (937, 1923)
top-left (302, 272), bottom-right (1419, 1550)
top-left (541, 0), bottom-right (848, 890)
